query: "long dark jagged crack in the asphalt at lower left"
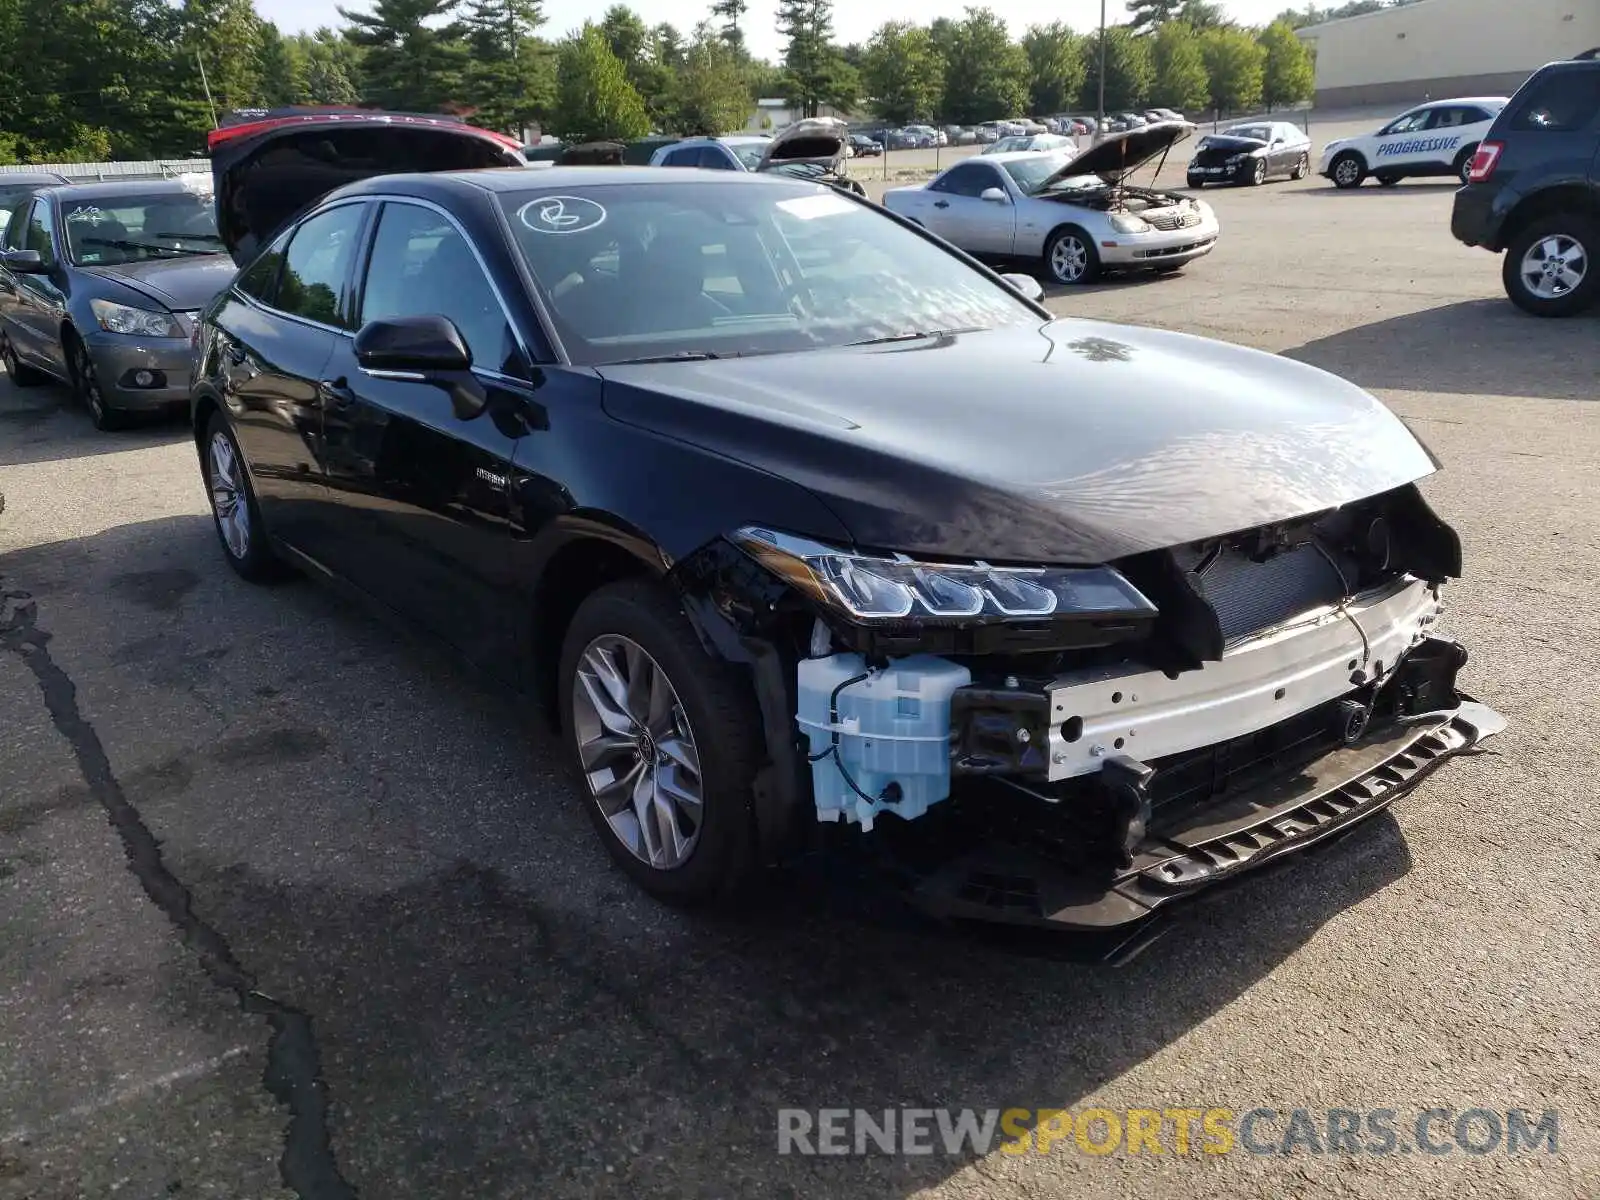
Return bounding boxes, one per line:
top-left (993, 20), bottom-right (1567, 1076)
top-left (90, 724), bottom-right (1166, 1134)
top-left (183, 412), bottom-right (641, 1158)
top-left (0, 592), bottom-right (357, 1200)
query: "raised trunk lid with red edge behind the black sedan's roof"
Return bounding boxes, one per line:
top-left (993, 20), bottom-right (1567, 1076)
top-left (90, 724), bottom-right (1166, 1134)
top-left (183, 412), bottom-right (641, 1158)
top-left (206, 109), bottom-right (525, 266)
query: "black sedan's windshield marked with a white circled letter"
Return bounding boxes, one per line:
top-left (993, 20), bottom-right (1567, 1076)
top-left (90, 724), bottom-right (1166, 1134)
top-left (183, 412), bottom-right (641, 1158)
top-left (499, 181), bottom-right (1038, 365)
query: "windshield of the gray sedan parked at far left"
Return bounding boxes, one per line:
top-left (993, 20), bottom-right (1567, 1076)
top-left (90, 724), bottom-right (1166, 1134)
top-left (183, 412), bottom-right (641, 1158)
top-left (61, 192), bottom-right (222, 267)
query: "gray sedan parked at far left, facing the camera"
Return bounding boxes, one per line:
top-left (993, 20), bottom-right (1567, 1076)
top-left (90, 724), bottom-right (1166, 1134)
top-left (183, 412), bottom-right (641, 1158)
top-left (0, 179), bottom-right (234, 429)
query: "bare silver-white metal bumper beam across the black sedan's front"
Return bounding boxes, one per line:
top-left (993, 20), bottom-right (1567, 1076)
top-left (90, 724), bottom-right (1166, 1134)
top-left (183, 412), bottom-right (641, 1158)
top-left (1048, 578), bottom-right (1443, 781)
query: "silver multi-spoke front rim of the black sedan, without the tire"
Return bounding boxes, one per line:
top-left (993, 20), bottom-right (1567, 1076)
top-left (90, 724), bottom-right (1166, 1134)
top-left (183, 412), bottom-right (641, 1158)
top-left (571, 634), bottom-right (706, 870)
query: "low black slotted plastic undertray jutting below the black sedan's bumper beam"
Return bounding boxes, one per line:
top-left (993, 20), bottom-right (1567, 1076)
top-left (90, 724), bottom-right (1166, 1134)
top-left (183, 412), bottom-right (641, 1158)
top-left (910, 701), bottom-right (1506, 931)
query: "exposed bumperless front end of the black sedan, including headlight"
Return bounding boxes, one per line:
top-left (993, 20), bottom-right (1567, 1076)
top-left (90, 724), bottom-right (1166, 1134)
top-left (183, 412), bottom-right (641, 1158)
top-left (674, 485), bottom-right (1502, 930)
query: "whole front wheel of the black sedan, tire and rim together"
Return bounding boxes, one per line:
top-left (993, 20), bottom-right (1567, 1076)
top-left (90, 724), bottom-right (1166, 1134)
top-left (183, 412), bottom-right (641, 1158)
top-left (560, 579), bottom-right (765, 904)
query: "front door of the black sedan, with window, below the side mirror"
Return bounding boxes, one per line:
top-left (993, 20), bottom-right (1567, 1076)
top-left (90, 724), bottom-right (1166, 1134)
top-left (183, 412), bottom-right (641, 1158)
top-left (312, 200), bottom-right (542, 670)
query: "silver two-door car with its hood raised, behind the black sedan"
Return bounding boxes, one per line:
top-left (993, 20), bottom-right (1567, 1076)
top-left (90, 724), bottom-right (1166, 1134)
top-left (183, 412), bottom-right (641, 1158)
top-left (883, 123), bottom-right (1221, 283)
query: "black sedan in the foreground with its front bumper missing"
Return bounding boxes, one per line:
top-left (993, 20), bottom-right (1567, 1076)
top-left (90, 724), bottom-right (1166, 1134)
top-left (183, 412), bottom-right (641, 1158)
top-left (194, 117), bottom-right (1501, 928)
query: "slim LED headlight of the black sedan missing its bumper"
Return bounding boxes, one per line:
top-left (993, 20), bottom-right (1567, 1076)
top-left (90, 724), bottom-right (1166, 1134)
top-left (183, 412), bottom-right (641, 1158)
top-left (731, 526), bottom-right (1155, 622)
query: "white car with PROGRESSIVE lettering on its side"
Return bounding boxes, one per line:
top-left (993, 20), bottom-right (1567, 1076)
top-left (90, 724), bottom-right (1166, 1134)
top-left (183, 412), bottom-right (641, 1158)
top-left (1317, 96), bottom-right (1510, 187)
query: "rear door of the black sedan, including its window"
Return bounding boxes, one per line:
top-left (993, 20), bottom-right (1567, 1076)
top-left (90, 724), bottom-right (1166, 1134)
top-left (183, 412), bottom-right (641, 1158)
top-left (200, 202), bottom-right (371, 566)
